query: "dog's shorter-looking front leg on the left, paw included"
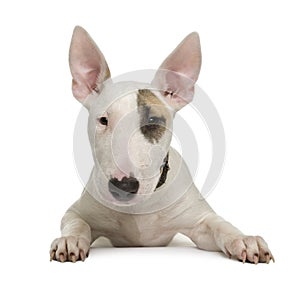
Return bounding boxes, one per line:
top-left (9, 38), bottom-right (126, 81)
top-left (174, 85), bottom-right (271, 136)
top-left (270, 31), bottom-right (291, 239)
top-left (50, 211), bottom-right (91, 262)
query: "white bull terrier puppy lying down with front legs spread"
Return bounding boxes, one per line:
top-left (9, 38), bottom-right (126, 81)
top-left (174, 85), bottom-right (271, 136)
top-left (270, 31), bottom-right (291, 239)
top-left (50, 26), bottom-right (274, 264)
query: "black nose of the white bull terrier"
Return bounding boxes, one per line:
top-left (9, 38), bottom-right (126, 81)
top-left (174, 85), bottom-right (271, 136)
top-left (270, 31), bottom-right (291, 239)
top-left (108, 177), bottom-right (140, 201)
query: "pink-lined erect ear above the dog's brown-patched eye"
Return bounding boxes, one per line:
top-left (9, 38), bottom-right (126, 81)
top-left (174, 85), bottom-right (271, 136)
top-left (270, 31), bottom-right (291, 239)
top-left (152, 32), bottom-right (201, 111)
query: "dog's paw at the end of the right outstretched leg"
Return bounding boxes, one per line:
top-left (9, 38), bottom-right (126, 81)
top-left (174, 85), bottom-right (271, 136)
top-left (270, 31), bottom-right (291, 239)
top-left (225, 236), bottom-right (275, 264)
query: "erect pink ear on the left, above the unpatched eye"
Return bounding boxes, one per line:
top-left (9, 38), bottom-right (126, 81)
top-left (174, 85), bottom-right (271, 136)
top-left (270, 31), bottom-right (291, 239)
top-left (69, 26), bottom-right (110, 103)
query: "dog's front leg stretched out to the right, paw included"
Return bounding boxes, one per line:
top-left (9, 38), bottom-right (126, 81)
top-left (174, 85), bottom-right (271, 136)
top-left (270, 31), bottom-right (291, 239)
top-left (184, 212), bottom-right (274, 263)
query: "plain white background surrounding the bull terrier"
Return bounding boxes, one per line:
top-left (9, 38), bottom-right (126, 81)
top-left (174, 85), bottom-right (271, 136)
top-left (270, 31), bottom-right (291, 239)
top-left (0, 0), bottom-right (300, 280)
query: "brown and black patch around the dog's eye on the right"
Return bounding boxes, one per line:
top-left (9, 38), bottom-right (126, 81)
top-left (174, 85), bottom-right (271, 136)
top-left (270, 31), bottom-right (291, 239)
top-left (137, 89), bottom-right (169, 143)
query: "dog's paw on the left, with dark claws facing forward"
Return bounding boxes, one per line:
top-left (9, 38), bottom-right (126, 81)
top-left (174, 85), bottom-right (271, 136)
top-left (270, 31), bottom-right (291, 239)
top-left (50, 236), bottom-right (90, 262)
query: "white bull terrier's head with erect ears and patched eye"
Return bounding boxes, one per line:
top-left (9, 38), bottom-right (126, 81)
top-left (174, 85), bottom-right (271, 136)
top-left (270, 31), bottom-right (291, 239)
top-left (70, 27), bottom-right (201, 203)
